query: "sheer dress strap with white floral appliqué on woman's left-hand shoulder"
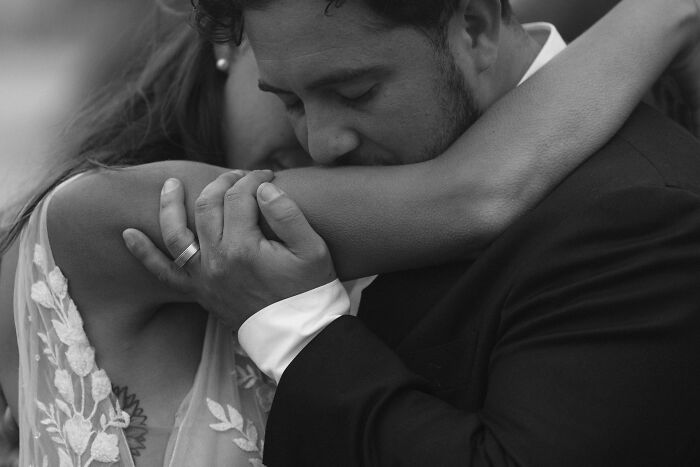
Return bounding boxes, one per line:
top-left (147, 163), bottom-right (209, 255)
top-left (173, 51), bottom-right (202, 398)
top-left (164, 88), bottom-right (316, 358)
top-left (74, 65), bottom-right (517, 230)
top-left (15, 175), bottom-right (133, 467)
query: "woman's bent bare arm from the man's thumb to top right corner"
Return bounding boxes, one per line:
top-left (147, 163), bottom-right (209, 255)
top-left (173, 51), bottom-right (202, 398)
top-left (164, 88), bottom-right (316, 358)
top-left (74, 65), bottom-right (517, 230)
top-left (276, 0), bottom-right (697, 278)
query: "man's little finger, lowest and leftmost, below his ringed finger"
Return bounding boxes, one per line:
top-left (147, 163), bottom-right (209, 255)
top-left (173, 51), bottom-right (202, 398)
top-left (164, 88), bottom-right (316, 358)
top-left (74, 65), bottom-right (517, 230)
top-left (122, 229), bottom-right (191, 294)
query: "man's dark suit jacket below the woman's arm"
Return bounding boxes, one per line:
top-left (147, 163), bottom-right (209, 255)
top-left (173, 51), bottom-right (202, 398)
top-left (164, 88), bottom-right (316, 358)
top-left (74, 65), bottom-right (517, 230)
top-left (265, 107), bottom-right (700, 467)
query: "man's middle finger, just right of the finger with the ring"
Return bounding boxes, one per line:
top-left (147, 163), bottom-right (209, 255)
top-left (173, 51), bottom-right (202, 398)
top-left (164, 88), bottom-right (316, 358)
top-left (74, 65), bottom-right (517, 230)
top-left (194, 170), bottom-right (247, 248)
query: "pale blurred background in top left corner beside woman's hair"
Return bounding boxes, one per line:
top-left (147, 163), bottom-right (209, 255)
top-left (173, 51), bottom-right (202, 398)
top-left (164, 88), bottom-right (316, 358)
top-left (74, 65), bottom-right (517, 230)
top-left (0, 0), bottom-right (185, 229)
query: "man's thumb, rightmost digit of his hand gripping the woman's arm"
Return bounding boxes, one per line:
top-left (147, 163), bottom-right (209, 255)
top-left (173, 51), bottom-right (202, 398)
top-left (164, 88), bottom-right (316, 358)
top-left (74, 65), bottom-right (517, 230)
top-left (257, 183), bottom-right (326, 257)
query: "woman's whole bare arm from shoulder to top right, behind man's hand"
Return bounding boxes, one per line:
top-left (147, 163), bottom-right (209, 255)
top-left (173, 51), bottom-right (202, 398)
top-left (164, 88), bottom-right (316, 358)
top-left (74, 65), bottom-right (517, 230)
top-left (49, 0), bottom-right (697, 311)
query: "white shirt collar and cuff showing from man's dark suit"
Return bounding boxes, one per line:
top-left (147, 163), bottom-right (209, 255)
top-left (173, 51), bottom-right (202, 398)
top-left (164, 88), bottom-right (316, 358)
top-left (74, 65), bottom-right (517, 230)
top-left (238, 23), bottom-right (566, 383)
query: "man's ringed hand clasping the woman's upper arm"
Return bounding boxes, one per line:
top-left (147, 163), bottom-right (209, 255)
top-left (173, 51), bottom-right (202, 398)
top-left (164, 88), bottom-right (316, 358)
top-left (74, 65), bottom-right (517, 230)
top-left (124, 171), bottom-right (336, 329)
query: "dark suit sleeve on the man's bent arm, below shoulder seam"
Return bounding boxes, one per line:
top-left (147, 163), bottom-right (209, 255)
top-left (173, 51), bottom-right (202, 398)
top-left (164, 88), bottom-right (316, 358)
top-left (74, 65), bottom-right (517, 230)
top-left (265, 187), bottom-right (700, 467)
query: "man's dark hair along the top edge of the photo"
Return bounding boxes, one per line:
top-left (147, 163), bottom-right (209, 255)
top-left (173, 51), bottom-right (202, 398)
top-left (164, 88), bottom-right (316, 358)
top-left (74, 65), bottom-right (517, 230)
top-left (192, 0), bottom-right (512, 44)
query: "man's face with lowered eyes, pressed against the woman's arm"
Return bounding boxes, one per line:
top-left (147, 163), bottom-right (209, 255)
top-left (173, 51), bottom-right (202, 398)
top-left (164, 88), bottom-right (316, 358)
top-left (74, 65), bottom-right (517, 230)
top-left (245, 0), bottom-right (477, 165)
